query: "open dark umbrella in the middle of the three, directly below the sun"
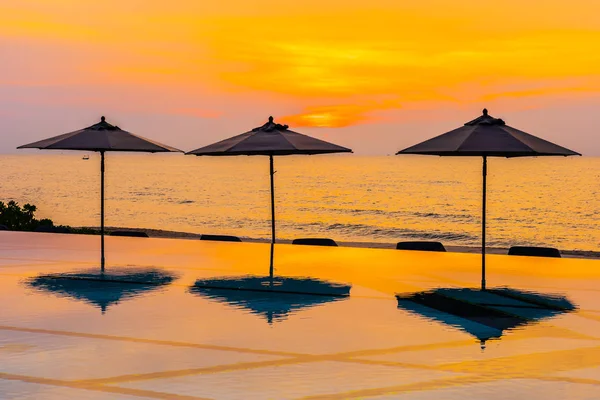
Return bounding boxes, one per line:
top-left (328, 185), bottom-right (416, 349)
top-left (186, 117), bottom-right (352, 269)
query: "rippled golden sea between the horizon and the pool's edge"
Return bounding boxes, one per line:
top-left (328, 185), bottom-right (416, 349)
top-left (0, 152), bottom-right (600, 251)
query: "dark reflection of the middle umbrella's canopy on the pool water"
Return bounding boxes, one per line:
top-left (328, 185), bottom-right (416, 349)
top-left (190, 276), bottom-right (351, 324)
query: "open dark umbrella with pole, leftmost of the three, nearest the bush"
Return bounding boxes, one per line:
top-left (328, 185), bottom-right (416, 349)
top-left (18, 117), bottom-right (181, 271)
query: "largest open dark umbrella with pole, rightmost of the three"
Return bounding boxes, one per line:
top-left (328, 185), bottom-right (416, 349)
top-left (396, 109), bottom-right (581, 290)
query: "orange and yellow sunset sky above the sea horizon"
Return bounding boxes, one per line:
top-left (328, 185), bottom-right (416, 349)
top-left (0, 0), bottom-right (600, 156)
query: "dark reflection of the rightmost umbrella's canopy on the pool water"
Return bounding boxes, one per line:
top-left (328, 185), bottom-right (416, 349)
top-left (396, 288), bottom-right (576, 348)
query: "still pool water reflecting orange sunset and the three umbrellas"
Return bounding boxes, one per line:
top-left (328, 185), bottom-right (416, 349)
top-left (0, 232), bottom-right (600, 400)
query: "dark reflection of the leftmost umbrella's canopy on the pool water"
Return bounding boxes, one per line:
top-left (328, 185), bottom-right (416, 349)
top-left (26, 268), bottom-right (176, 314)
